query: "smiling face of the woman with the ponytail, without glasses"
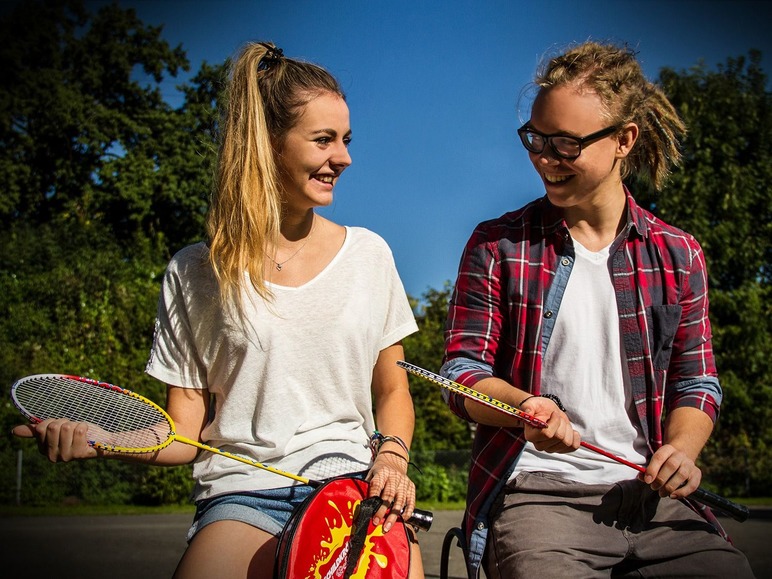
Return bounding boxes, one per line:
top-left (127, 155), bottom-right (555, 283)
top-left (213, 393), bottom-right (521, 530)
top-left (278, 93), bottom-right (351, 212)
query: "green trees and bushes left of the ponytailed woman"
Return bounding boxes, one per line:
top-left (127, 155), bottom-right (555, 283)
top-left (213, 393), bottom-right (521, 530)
top-left (0, 0), bottom-right (217, 503)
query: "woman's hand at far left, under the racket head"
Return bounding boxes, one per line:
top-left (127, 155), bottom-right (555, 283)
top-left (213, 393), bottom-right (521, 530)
top-left (11, 418), bottom-right (98, 462)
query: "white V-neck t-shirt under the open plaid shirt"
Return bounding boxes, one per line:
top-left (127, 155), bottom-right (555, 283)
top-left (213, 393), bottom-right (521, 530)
top-left (512, 240), bottom-right (646, 484)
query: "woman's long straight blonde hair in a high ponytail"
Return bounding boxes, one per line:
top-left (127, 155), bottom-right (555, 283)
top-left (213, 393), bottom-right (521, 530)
top-left (207, 42), bottom-right (345, 305)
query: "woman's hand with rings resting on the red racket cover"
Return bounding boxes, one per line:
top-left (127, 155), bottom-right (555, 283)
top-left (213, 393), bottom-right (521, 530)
top-left (367, 446), bottom-right (415, 533)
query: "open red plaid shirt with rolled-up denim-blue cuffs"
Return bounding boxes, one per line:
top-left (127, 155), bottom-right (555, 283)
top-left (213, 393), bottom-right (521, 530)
top-left (441, 193), bottom-right (721, 566)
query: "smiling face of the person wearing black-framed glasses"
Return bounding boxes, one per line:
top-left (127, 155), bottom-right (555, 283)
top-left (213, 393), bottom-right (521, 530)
top-left (528, 85), bottom-right (637, 209)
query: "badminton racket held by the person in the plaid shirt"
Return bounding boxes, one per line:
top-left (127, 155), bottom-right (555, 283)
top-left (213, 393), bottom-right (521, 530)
top-left (397, 360), bottom-right (750, 522)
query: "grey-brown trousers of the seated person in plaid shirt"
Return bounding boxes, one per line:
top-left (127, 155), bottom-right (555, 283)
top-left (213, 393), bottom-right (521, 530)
top-left (484, 473), bottom-right (753, 579)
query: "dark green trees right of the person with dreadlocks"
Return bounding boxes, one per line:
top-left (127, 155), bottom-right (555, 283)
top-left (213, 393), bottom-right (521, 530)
top-left (633, 51), bottom-right (772, 494)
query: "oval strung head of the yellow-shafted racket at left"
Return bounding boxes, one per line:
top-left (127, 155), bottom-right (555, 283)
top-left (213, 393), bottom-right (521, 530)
top-left (11, 374), bottom-right (175, 453)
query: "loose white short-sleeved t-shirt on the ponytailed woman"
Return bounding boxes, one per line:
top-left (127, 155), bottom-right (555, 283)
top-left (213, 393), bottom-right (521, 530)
top-left (146, 227), bottom-right (418, 500)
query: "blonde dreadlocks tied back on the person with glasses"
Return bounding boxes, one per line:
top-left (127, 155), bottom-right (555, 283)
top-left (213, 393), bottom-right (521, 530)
top-left (535, 42), bottom-right (686, 189)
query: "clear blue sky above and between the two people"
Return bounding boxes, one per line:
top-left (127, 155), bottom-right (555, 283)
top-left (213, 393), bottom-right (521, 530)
top-left (89, 0), bottom-right (772, 297)
